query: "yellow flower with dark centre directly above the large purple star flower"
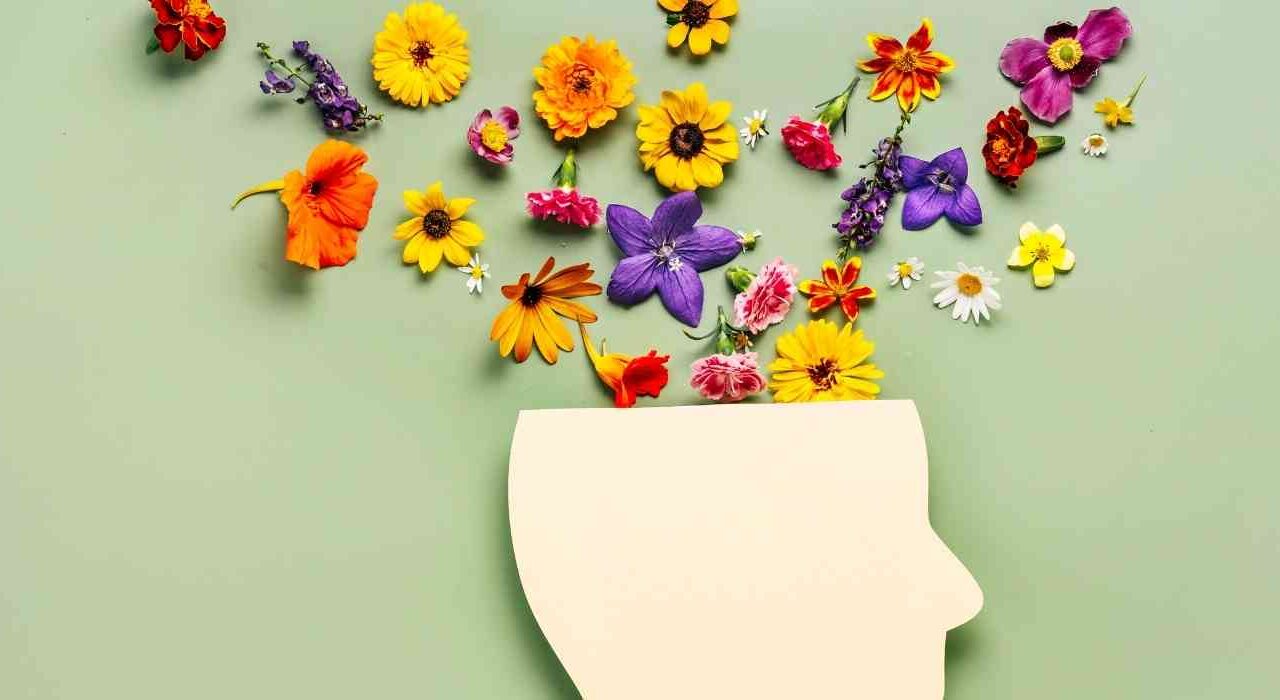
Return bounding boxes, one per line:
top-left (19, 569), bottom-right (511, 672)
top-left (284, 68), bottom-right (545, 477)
top-left (636, 83), bottom-right (739, 192)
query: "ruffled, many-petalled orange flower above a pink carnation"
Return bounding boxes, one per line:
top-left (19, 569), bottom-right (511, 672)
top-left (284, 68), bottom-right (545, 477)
top-left (534, 36), bottom-right (636, 141)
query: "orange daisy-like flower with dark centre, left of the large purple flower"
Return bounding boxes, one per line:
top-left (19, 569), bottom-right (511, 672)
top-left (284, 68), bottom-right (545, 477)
top-left (489, 257), bottom-right (600, 365)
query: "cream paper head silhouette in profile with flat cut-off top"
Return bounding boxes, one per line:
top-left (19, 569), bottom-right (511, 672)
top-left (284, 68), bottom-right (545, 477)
top-left (508, 402), bottom-right (982, 700)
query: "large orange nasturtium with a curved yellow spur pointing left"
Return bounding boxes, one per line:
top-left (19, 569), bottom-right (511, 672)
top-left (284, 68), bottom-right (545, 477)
top-left (232, 139), bottom-right (378, 270)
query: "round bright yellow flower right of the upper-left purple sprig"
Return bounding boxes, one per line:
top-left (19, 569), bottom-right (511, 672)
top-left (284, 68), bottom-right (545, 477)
top-left (371, 3), bottom-right (471, 107)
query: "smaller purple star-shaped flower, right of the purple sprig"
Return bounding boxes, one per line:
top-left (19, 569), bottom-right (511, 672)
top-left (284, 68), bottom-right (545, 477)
top-left (897, 148), bottom-right (982, 230)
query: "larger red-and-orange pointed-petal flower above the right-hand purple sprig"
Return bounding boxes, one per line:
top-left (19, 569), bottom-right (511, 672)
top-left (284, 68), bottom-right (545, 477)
top-left (858, 17), bottom-right (956, 111)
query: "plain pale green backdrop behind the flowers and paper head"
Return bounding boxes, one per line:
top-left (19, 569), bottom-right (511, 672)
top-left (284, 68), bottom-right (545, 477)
top-left (0, 0), bottom-right (1280, 700)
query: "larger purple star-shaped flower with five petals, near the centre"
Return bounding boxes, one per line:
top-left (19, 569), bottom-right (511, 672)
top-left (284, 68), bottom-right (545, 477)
top-left (604, 192), bottom-right (742, 328)
